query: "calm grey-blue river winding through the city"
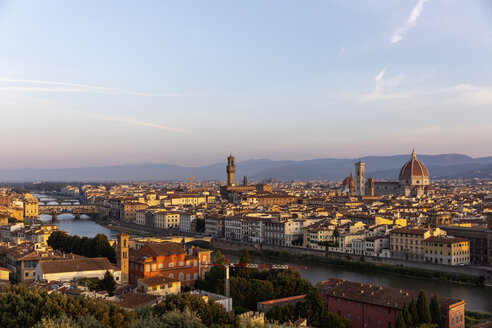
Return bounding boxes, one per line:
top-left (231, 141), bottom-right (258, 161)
top-left (40, 195), bottom-right (492, 312)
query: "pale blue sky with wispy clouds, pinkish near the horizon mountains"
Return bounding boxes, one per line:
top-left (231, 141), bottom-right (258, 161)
top-left (0, 0), bottom-right (492, 169)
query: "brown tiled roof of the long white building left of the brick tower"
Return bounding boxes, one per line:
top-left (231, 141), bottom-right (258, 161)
top-left (39, 257), bottom-right (115, 274)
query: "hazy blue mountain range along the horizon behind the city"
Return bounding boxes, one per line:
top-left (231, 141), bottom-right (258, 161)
top-left (0, 154), bottom-right (492, 182)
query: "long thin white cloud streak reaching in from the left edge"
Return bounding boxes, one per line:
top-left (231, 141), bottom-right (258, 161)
top-left (0, 77), bottom-right (192, 97)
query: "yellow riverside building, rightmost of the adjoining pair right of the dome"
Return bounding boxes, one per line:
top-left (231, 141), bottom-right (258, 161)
top-left (424, 236), bottom-right (470, 265)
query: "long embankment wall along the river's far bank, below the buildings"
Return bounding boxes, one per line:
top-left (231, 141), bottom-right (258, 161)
top-left (210, 239), bottom-right (492, 285)
